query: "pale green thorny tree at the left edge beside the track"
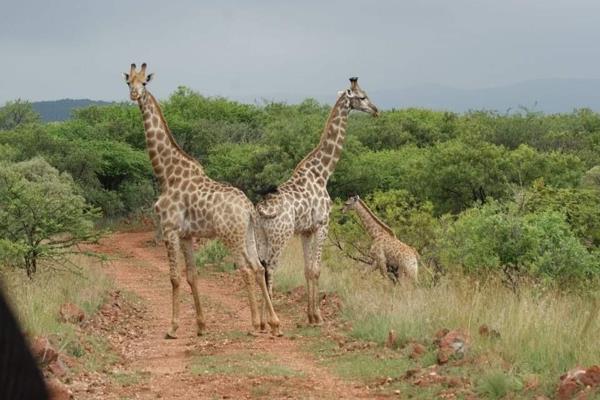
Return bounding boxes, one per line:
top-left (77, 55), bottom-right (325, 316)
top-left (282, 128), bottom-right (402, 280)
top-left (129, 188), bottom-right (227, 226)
top-left (0, 158), bottom-right (99, 277)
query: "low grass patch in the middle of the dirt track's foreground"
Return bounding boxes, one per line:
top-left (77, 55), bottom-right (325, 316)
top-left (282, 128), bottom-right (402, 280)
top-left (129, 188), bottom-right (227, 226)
top-left (190, 352), bottom-right (302, 377)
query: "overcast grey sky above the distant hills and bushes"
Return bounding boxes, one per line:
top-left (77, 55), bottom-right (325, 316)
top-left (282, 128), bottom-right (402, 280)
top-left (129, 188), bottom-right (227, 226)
top-left (0, 0), bottom-right (600, 103)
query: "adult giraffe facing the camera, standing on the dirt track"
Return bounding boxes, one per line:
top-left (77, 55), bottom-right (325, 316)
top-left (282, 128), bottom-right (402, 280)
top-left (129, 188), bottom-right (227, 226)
top-left (124, 63), bottom-right (280, 338)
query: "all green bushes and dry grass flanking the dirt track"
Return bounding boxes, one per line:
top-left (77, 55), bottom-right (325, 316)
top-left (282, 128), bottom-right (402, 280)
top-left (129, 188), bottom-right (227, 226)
top-left (0, 87), bottom-right (600, 398)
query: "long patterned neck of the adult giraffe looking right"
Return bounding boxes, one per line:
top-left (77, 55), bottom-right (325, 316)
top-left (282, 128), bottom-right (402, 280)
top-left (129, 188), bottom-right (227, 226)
top-left (294, 93), bottom-right (350, 181)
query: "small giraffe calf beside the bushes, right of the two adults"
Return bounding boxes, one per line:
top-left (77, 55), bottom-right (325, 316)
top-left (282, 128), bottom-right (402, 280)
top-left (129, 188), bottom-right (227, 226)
top-left (342, 196), bottom-right (419, 282)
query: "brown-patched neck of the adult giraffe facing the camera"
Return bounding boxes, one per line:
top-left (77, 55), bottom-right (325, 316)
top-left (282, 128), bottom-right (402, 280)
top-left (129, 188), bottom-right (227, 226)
top-left (138, 91), bottom-right (203, 189)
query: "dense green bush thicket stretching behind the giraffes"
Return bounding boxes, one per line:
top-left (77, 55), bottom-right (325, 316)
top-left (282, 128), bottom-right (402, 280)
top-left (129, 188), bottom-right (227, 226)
top-left (0, 88), bottom-right (600, 287)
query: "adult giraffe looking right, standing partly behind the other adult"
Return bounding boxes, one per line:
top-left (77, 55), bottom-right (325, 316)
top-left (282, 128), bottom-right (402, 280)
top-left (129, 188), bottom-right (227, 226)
top-left (256, 78), bottom-right (379, 328)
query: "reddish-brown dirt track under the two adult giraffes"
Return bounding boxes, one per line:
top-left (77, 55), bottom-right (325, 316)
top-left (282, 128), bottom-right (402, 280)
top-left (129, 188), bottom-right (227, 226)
top-left (72, 232), bottom-right (377, 399)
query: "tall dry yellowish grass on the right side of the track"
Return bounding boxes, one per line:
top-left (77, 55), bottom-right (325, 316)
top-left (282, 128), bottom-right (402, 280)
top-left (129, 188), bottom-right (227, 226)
top-left (275, 241), bottom-right (600, 398)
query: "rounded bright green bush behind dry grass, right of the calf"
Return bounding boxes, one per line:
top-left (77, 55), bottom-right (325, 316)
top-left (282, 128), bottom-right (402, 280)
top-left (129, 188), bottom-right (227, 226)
top-left (439, 202), bottom-right (600, 284)
